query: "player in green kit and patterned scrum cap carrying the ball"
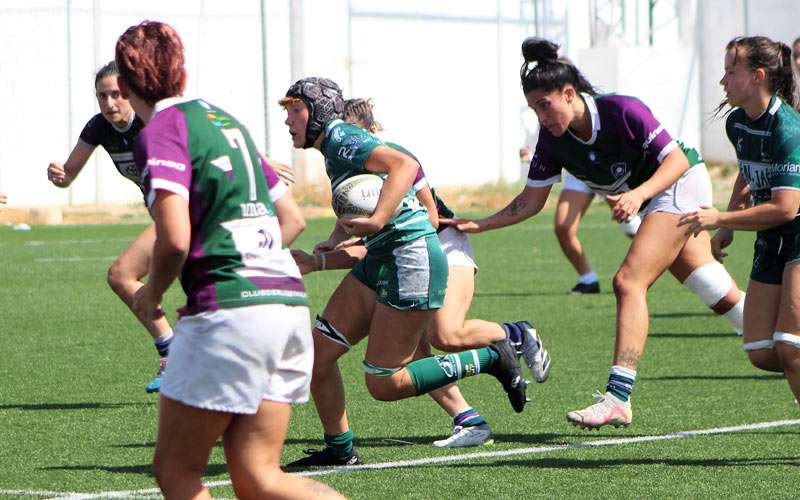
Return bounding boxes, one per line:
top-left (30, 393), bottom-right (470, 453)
top-left (280, 78), bottom-right (527, 467)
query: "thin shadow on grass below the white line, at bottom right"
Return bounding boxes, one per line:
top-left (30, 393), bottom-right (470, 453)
top-left (444, 456), bottom-right (800, 469)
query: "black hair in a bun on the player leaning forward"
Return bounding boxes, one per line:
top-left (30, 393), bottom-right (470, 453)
top-left (519, 36), bottom-right (597, 95)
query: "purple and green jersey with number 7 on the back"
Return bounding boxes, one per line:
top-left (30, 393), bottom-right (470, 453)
top-left (134, 99), bottom-right (308, 314)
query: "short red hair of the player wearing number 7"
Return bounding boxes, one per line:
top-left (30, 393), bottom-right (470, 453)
top-left (114, 21), bottom-right (186, 106)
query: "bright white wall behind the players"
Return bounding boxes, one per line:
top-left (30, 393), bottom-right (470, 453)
top-left (0, 0), bottom-right (800, 206)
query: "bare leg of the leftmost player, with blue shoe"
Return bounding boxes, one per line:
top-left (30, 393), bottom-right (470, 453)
top-left (108, 224), bottom-right (172, 392)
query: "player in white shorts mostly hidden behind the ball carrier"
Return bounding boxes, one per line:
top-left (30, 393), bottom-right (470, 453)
top-left (292, 95), bottom-right (550, 448)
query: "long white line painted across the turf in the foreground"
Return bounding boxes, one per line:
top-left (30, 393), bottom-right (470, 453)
top-left (0, 419), bottom-right (800, 500)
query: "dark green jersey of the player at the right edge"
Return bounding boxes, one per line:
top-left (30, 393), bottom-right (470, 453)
top-left (725, 96), bottom-right (800, 233)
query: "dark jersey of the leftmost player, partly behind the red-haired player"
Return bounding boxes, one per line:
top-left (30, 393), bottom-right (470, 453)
top-left (80, 113), bottom-right (144, 188)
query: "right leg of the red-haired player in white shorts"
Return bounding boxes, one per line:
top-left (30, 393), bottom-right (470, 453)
top-left (224, 400), bottom-right (344, 498)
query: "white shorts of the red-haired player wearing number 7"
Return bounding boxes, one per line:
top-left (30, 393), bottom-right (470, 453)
top-left (161, 304), bottom-right (314, 414)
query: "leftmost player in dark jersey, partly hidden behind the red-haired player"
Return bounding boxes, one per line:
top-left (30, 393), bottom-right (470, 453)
top-left (47, 61), bottom-right (172, 393)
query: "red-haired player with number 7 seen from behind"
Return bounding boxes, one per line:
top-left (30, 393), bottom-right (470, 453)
top-left (116, 21), bottom-right (341, 498)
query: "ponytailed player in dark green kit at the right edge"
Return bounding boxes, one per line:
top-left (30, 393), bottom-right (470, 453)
top-left (681, 36), bottom-right (800, 406)
